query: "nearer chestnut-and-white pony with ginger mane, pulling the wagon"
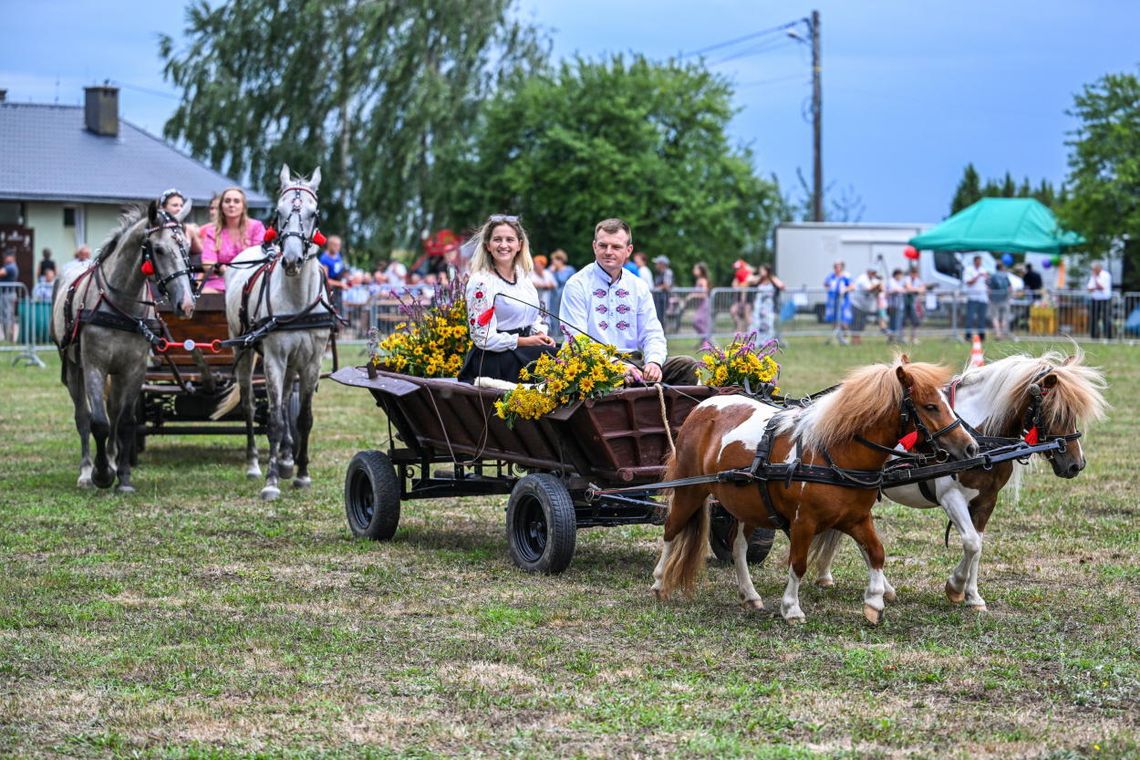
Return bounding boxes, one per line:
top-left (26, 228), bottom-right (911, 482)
top-left (653, 357), bottom-right (978, 623)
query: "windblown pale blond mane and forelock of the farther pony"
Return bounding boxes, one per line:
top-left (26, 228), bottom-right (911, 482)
top-left (960, 346), bottom-right (1108, 435)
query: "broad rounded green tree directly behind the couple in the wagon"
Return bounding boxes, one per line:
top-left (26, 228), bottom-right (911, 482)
top-left (450, 56), bottom-right (784, 281)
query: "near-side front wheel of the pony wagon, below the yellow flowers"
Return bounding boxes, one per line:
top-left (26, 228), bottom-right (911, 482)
top-left (506, 473), bottom-right (578, 575)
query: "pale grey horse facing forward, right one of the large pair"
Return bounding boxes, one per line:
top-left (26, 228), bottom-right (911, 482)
top-left (214, 165), bottom-right (336, 500)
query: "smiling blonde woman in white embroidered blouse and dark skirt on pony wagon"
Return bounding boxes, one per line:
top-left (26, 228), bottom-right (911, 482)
top-left (459, 215), bottom-right (554, 383)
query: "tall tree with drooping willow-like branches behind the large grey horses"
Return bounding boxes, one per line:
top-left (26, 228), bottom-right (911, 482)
top-left (160, 0), bottom-right (544, 248)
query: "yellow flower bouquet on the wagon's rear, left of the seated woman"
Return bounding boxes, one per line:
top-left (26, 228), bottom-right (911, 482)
top-left (369, 279), bottom-right (471, 377)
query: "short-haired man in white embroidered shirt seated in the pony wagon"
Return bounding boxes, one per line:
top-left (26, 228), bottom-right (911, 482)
top-left (559, 219), bottom-right (697, 385)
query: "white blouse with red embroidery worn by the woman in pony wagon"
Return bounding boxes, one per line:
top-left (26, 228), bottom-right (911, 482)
top-left (466, 267), bottom-right (546, 351)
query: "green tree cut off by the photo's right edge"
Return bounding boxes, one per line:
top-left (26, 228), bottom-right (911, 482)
top-left (1059, 66), bottom-right (1140, 282)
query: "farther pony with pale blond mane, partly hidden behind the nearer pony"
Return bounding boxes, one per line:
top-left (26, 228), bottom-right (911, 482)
top-left (813, 349), bottom-right (1108, 611)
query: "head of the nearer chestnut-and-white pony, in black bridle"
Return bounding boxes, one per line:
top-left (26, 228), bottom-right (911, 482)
top-left (895, 354), bottom-right (978, 459)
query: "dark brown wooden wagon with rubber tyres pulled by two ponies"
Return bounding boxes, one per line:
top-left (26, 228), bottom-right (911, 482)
top-left (332, 367), bottom-right (773, 573)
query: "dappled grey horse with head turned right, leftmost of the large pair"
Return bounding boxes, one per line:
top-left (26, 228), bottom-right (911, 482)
top-left (51, 201), bottom-right (195, 493)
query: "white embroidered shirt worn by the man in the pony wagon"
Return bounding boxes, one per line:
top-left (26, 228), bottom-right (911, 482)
top-left (559, 262), bottom-right (668, 366)
